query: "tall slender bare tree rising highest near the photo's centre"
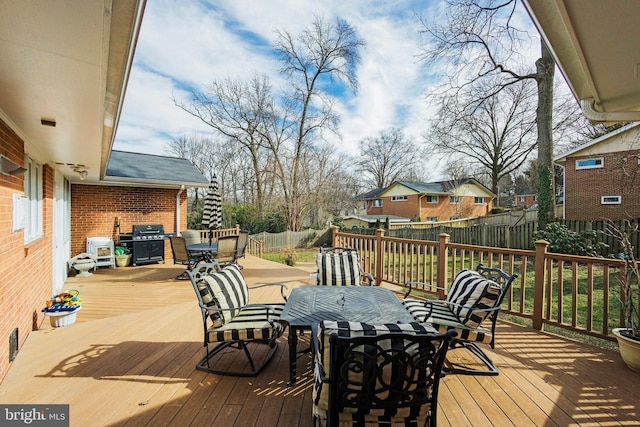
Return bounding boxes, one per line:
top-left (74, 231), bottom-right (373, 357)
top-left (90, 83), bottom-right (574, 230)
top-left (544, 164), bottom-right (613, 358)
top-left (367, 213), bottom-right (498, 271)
top-left (274, 17), bottom-right (364, 230)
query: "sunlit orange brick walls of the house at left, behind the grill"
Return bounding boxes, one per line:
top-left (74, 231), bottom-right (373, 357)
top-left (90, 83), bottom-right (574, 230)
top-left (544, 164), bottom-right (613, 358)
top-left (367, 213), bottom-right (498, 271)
top-left (0, 113), bottom-right (207, 378)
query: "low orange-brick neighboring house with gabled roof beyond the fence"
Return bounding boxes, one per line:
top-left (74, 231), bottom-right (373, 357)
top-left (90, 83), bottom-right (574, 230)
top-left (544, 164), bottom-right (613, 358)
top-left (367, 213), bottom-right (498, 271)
top-left (358, 178), bottom-right (496, 221)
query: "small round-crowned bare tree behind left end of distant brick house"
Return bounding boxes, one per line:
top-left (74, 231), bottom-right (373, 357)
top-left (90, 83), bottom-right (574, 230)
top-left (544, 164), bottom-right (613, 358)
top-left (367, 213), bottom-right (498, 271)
top-left (356, 128), bottom-right (421, 188)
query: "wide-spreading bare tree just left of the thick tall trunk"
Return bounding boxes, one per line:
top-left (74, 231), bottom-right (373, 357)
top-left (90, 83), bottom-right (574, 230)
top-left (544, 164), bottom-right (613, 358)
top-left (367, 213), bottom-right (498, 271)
top-left (430, 78), bottom-right (536, 202)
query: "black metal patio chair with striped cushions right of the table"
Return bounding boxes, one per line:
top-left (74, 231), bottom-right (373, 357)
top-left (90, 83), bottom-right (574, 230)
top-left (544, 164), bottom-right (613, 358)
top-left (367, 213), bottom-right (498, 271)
top-left (402, 264), bottom-right (518, 375)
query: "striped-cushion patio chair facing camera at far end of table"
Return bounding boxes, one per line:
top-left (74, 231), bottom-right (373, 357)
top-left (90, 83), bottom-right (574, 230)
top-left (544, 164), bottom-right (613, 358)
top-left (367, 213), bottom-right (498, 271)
top-left (316, 248), bottom-right (375, 286)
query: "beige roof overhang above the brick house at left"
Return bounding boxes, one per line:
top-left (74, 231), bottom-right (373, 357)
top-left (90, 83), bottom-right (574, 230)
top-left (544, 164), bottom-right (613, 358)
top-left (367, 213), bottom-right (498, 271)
top-left (0, 0), bottom-right (145, 183)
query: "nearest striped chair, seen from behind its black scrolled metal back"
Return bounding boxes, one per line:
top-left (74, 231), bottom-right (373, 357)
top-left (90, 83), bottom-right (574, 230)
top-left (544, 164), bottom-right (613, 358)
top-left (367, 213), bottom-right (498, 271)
top-left (313, 320), bottom-right (435, 426)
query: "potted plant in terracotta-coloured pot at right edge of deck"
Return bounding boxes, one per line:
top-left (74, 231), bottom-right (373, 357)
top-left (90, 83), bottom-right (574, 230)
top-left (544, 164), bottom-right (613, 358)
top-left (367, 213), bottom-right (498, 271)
top-left (607, 222), bottom-right (640, 372)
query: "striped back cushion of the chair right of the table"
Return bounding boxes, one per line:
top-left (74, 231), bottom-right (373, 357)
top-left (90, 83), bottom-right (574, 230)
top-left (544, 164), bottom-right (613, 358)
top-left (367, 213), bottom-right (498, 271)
top-left (447, 270), bottom-right (501, 328)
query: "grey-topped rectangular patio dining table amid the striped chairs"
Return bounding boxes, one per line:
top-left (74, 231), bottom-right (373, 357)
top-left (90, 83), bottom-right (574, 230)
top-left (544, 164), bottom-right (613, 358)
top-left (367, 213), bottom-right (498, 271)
top-left (280, 285), bottom-right (415, 385)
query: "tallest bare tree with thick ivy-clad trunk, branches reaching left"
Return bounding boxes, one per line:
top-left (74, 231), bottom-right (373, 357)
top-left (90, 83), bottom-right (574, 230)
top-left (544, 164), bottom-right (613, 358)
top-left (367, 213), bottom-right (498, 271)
top-left (420, 0), bottom-right (555, 229)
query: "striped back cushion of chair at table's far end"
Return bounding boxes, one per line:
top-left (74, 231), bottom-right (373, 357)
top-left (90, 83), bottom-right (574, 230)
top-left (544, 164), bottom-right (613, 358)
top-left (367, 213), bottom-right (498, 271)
top-left (316, 251), bottom-right (362, 286)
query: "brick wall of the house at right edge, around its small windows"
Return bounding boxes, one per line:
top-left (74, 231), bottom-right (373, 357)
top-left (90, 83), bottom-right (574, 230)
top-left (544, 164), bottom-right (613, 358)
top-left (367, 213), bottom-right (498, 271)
top-left (564, 150), bottom-right (640, 220)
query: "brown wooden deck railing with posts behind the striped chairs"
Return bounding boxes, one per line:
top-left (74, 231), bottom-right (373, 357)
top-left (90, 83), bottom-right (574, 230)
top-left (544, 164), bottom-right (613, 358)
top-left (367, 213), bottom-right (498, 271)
top-left (332, 227), bottom-right (636, 340)
